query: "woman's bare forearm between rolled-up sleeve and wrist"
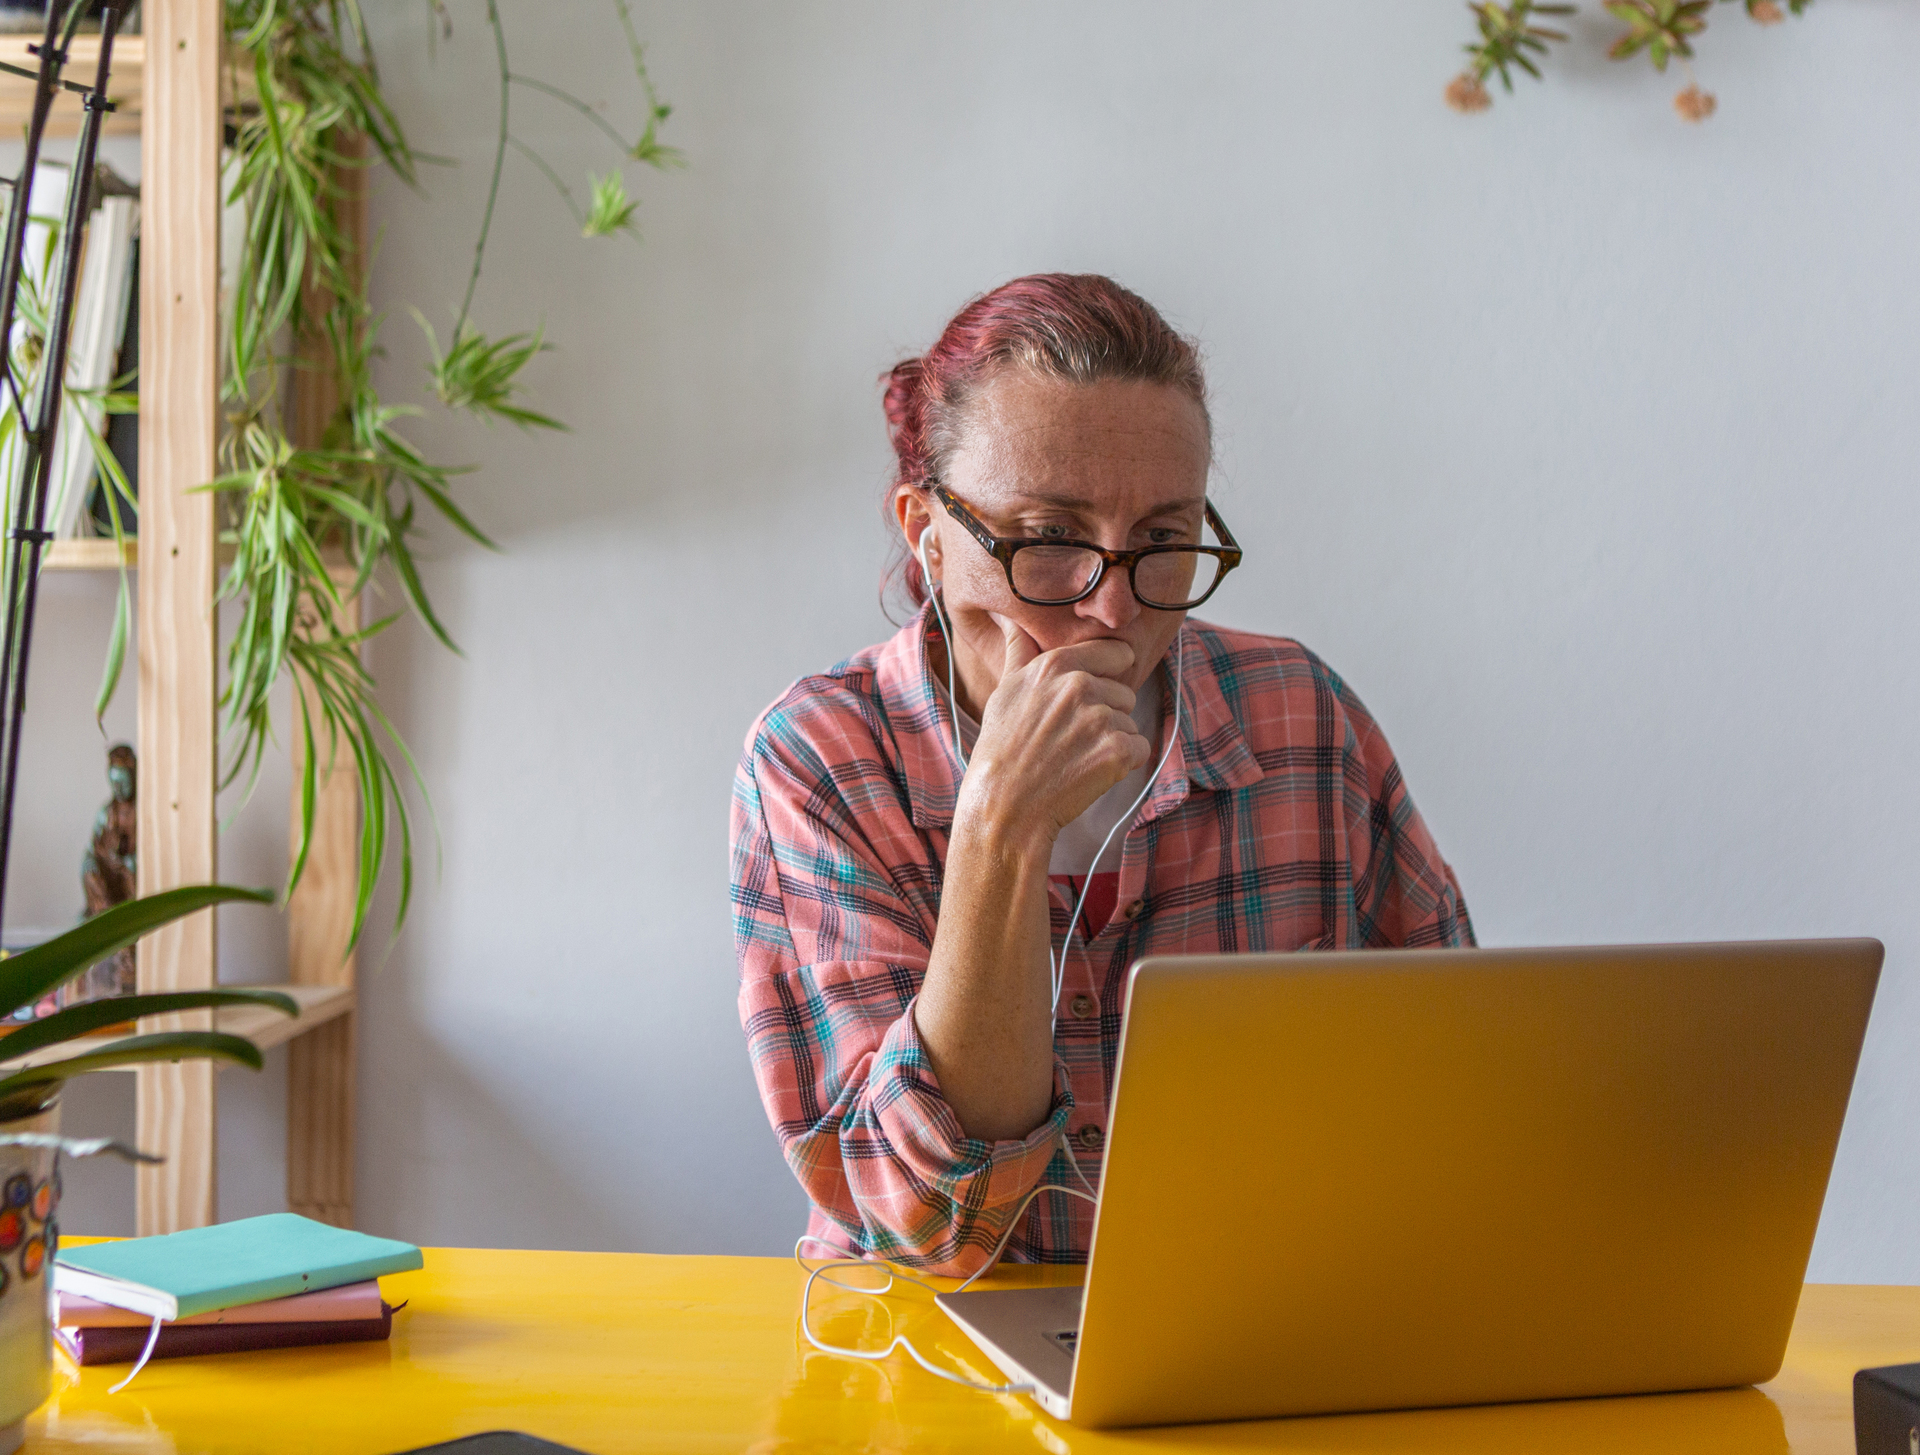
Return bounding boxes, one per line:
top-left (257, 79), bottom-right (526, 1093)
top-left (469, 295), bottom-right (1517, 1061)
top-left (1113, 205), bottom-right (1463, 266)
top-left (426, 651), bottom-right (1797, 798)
top-left (914, 804), bottom-right (1054, 1142)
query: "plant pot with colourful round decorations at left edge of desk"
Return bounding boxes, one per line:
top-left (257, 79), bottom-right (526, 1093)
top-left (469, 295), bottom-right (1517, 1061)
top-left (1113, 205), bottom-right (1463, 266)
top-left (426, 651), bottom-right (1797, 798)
top-left (0, 1106), bottom-right (60, 1455)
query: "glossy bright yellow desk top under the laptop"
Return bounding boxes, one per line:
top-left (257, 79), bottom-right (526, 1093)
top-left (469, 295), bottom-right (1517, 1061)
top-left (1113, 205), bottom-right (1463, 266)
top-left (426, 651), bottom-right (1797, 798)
top-left (27, 1248), bottom-right (1920, 1455)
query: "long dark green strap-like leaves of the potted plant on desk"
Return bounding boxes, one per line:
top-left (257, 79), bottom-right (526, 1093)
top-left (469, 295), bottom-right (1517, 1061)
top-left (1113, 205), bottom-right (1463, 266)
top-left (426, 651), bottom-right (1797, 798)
top-left (0, 885), bottom-right (300, 1123)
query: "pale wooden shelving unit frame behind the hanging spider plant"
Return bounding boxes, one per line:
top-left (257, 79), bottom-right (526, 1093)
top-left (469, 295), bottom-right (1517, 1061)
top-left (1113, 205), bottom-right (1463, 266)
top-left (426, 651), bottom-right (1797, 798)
top-left (14, 0), bottom-right (365, 1234)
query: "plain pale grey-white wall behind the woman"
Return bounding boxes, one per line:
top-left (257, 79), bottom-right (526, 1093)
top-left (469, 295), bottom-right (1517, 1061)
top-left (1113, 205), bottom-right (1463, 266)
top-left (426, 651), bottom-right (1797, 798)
top-left (22, 0), bottom-right (1920, 1282)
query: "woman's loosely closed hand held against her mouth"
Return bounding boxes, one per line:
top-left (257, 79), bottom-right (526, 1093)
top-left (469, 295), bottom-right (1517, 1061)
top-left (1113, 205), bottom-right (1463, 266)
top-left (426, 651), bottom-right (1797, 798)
top-left (954, 614), bottom-right (1154, 848)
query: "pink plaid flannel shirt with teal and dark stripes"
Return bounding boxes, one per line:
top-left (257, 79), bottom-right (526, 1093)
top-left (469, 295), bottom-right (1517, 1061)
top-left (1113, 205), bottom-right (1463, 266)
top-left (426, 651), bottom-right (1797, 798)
top-left (732, 608), bottom-right (1473, 1273)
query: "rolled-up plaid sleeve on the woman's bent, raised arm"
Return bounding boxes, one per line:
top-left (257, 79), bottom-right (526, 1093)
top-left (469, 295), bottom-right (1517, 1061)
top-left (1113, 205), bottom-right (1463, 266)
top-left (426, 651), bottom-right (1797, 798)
top-left (732, 706), bottom-right (1073, 1273)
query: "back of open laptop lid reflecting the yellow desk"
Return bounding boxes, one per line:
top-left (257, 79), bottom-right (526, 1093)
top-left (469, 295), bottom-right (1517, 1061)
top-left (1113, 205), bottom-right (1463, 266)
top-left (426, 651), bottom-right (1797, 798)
top-left (1071, 941), bottom-right (1882, 1426)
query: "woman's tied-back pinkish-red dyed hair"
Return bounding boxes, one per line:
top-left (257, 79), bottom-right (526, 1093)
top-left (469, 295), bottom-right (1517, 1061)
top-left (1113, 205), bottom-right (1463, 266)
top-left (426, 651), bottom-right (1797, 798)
top-left (881, 273), bottom-right (1212, 607)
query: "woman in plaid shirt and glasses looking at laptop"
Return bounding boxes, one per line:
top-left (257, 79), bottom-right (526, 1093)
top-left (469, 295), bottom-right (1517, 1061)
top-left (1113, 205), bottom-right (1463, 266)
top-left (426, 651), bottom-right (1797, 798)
top-left (733, 274), bottom-right (1473, 1273)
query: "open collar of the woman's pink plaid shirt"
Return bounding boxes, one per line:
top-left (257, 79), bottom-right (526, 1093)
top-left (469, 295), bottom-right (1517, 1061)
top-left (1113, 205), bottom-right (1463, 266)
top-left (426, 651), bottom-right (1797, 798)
top-left (874, 605), bottom-right (1263, 829)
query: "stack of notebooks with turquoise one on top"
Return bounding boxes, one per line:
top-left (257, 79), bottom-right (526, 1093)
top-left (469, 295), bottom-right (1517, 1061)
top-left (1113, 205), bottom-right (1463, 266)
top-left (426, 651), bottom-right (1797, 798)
top-left (54, 1213), bottom-right (420, 1365)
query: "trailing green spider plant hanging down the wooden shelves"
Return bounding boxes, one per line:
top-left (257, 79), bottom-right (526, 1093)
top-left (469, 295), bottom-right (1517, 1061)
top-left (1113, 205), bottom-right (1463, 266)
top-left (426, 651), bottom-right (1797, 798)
top-left (82, 0), bottom-right (680, 942)
